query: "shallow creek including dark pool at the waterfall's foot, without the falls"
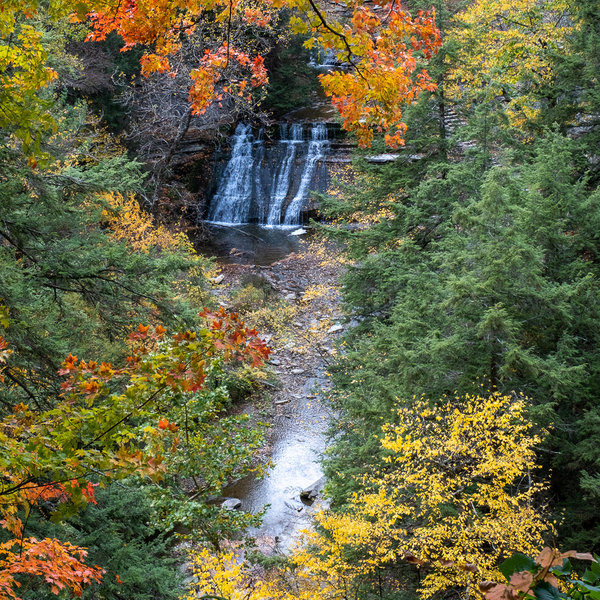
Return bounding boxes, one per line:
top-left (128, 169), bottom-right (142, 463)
top-left (206, 227), bottom-right (343, 553)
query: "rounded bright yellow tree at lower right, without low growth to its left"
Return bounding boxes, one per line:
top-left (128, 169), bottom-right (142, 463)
top-left (370, 393), bottom-right (547, 596)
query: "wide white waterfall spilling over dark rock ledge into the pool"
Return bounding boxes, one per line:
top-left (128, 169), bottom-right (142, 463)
top-left (208, 123), bottom-right (329, 227)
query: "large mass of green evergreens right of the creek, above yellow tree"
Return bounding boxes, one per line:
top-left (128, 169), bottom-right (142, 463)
top-left (327, 133), bottom-right (600, 545)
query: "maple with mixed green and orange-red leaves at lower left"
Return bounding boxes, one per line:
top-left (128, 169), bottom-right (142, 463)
top-left (0, 310), bottom-right (269, 600)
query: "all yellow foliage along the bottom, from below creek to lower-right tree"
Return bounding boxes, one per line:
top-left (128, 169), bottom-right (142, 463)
top-left (189, 393), bottom-right (547, 599)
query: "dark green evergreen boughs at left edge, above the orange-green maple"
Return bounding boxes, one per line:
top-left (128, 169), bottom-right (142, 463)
top-left (0, 137), bottom-right (203, 404)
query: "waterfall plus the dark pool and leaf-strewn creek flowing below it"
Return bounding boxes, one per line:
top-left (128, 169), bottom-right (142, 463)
top-left (200, 117), bottom-right (343, 553)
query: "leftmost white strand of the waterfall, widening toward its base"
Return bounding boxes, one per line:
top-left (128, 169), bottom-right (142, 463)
top-left (208, 123), bottom-right (254, 224)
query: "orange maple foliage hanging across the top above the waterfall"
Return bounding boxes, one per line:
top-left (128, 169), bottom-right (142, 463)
top-left (0, 0), bottom-right (441, 151)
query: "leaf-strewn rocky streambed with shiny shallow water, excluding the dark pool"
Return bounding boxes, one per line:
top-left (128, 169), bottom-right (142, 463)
top-left (207, 240), bottom-right (345, 553)
